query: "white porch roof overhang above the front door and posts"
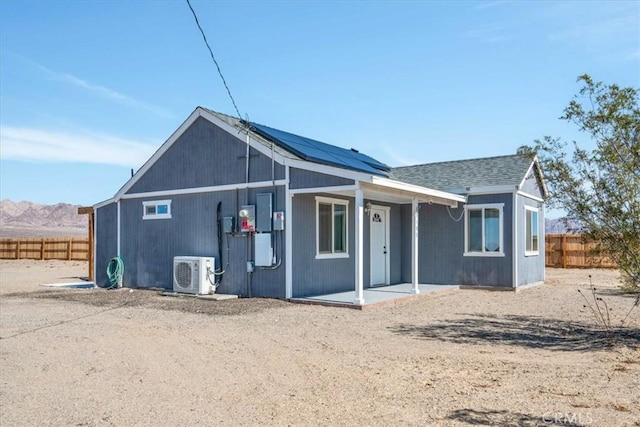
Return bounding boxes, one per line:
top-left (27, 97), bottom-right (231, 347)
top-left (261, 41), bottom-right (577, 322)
top-left (290, 176), bottom-right (467, 207)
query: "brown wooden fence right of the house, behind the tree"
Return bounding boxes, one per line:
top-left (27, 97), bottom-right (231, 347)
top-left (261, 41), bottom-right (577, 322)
top-left (545, 234), bottom-right (618, 268)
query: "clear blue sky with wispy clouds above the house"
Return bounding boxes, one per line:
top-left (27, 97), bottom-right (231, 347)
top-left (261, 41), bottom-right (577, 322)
top-left (0, 0), bottom-right (640, 214)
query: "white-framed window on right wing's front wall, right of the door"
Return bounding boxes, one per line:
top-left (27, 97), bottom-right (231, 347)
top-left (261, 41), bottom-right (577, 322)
top-left (464, 203), bottom-right (504, 256)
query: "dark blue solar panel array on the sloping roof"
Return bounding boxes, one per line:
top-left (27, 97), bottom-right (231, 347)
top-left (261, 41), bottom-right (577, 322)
top-left (251, 123), bottom-right (391, 176)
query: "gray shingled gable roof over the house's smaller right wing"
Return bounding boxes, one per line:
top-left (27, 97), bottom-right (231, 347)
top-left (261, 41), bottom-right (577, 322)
top-left (390, 154), bottom-right (546, 193)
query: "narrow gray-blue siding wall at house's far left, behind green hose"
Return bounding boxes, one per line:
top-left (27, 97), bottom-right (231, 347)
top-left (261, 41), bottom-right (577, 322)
top-left (95, 203), bottom-right (118, 287)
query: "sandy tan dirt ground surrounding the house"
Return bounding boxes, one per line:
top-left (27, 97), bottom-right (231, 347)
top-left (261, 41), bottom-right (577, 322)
top-left (0, 260), bottom-right (640, 426)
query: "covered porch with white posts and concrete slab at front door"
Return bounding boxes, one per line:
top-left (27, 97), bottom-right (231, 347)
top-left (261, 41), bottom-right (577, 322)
top-left (287, 176), bottom-right (466, 307)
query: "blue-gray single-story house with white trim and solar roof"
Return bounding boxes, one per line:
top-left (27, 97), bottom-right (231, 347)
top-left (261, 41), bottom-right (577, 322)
top-left (94, 107), bottom-right (546, 305)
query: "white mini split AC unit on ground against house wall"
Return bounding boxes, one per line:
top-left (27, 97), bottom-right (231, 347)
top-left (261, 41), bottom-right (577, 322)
top-left (173, 256), bottom-right (216, 294)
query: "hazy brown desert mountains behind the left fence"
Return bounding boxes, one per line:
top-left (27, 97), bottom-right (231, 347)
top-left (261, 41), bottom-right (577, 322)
top-left (0, 199), bottom-right (88, 238)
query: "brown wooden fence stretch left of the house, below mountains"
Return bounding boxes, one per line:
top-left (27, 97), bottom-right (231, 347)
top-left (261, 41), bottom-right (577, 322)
top-left (0, 238), bottom-right (91, 261)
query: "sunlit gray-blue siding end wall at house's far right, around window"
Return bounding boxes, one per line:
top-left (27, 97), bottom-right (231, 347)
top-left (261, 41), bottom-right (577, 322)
top-left (517, 196), bottom-right (545, 286)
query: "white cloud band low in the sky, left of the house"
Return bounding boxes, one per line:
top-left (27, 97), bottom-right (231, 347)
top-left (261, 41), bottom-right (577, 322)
top-left (0, 125), bottom-right (158, 167)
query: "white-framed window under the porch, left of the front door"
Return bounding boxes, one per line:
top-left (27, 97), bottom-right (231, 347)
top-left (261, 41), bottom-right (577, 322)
top-left (316, 196), bottom-right (349, 258)
